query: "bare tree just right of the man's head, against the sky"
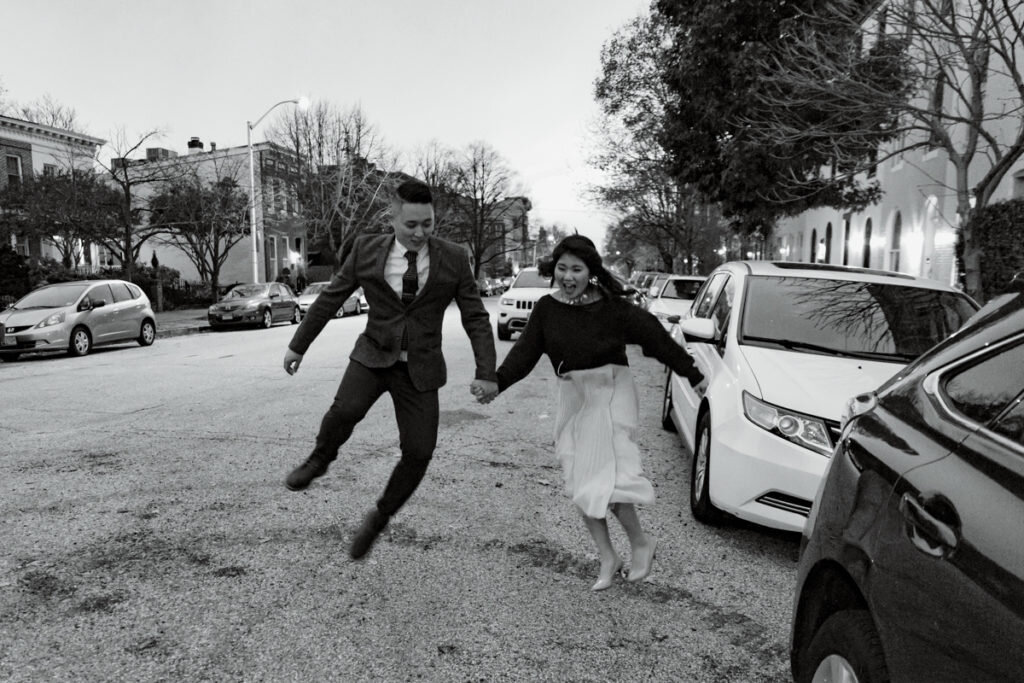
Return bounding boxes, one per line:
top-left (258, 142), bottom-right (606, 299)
top-left (439, 142), bottom-right (530, 276)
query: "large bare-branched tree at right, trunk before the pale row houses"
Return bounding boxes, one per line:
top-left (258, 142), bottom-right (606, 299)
top-left (746, 0), bottom-right (1024, 296)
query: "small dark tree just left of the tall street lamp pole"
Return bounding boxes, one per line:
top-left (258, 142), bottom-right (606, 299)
top-left (148, 174), bottom-right (249, 301)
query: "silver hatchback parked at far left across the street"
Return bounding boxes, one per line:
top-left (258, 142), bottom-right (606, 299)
top-left (0, 280), bottom-right (157, 362)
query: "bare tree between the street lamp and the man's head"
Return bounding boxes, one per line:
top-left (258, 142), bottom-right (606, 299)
top-left (267, 101), bottom-right (397, 258)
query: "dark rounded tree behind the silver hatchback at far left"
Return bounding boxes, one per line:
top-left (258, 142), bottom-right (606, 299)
top-left (0, 167), bottom-right (119, 268)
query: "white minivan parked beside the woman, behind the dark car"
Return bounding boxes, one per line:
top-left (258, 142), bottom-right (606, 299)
top-left (662, 261), bottom-right (977, 531)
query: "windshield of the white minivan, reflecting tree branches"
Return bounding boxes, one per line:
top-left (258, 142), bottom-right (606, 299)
top-left (740, 275), bottom-right (975, 360)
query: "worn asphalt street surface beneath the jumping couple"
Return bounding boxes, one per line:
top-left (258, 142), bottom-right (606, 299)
top-left (0, 299), bottom-right (798, 682)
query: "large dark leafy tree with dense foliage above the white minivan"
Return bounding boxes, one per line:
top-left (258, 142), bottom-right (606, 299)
top-left (654, 0), bottom-right (903, 233)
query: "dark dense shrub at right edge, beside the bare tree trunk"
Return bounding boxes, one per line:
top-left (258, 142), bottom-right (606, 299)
top-left (957, 199), bottom-right (1024, 301)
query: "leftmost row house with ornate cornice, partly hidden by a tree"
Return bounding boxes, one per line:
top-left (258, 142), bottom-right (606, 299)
top-left (0, 116), bottom-right (106, 263)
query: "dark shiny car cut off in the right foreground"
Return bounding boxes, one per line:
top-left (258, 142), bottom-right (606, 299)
top-left (791, 295), bottom-right (1024, 683)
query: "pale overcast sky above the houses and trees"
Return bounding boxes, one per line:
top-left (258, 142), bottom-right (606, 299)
top-left (0, 0), bottom-right (649, 249)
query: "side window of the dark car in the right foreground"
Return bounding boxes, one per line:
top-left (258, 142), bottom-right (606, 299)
top-left (942, 344), bottom-right (1024, 425)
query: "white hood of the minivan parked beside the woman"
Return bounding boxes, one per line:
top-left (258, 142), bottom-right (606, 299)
top-left (739, 345), bottom-right (905, 421)
